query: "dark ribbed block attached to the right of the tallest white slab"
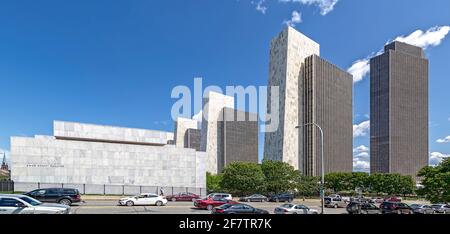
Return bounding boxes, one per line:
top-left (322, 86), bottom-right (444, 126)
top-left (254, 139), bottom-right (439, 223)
top-left (299, 55), bottom-right (353, 176)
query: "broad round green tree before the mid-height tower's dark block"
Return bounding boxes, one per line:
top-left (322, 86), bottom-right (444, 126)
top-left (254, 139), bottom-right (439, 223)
top-left (220, 162), bottom-right (265, 196)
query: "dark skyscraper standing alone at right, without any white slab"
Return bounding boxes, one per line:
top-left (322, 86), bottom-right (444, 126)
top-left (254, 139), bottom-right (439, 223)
top-left (370, 42), bottom-right (428, 176)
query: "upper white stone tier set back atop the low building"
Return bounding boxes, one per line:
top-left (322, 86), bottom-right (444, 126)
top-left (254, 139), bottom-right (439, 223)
top-left (53, 121), bottom-right (174, 145)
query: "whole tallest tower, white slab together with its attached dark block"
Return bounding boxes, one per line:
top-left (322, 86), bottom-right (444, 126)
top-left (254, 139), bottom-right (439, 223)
top-left (264, 27), bottom-right (353, 176)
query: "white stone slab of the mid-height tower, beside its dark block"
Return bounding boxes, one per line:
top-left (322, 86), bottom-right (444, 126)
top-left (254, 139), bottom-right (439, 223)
top-left (200, 92), bottom-right (234, 174)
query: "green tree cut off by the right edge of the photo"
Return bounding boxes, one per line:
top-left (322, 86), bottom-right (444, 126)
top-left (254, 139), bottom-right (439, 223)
top-left (417, 158), bottom-right (450, 203)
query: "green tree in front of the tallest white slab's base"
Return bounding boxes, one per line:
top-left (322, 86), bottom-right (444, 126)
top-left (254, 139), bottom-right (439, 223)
top-left (261, 160), bottom-right (296, 193)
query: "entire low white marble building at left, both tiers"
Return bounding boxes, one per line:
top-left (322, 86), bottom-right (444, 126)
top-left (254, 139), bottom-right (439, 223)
top-left (11, 121), bottom-right (206, 191)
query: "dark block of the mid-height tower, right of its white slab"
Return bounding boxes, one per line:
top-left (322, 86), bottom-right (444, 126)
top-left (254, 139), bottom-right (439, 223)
top-left (218, 107), bottom-right (258, 172)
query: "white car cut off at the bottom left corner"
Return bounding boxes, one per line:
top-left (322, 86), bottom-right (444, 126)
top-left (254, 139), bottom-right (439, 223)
top-left (0, 194), bottom-right (70, 215)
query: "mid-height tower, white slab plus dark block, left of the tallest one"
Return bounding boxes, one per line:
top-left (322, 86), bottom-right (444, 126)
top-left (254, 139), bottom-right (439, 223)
top-left (200, 92), bottom-right (258, 174)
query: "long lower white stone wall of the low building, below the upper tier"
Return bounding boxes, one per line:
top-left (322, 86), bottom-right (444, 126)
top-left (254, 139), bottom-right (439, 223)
top-left (11, 137), bottom-right (206, 188)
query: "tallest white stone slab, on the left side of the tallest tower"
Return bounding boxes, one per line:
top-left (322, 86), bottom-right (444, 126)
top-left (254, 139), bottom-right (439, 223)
top-left (264, 27), bottom-right (320, 169)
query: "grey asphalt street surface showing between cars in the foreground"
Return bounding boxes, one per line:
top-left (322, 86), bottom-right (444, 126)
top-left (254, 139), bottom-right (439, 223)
top-left (72, 199), bottom-right (347, 214)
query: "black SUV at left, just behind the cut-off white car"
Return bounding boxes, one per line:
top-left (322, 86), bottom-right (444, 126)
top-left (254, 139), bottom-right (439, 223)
top-left (24, 188), bottom-right (81, 206)
